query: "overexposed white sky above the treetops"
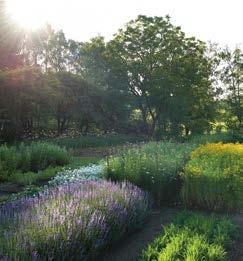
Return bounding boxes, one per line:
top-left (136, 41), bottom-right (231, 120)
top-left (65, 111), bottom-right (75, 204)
top-left (6, 0), bottom-right (243, 48)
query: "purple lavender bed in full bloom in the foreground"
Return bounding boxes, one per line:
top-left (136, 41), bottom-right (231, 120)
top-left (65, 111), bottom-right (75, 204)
top-left (0, 180), bottom-right (151, 260)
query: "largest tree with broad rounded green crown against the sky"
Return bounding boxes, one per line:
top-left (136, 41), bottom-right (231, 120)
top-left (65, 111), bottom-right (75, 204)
top-left (110, 16), bottom-right (213, 135)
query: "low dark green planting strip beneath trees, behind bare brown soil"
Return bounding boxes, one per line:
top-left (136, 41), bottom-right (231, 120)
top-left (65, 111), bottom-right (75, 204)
top-left (52, 135), bottom-right (146, 149)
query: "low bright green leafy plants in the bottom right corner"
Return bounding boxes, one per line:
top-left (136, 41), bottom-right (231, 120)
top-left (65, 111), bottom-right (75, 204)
top-left (140, 211), bottom-right (237, 261)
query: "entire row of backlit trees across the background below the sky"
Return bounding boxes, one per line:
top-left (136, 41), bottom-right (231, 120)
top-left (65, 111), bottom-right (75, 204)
top-left (0, 1), bottom-right (243, 140)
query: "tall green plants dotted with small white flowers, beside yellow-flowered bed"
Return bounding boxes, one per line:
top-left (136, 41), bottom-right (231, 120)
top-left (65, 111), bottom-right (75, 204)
top-left (106, 142), bottom-right (194, 205)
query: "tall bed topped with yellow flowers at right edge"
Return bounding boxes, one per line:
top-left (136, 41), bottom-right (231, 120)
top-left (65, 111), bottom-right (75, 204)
top-left (182, 143), bottom-right (243, 211)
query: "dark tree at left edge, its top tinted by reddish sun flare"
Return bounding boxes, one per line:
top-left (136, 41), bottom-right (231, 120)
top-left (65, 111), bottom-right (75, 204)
top-left (0, 67), bottom-right (41, 139)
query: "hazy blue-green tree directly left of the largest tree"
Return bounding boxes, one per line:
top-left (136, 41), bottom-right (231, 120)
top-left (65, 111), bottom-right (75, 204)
top-left (73, 37), bottom-right (130, 131)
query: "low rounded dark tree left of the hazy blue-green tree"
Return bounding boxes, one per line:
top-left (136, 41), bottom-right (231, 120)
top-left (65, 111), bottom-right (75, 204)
top-left (45, 72), bottom-right (99, 134)
